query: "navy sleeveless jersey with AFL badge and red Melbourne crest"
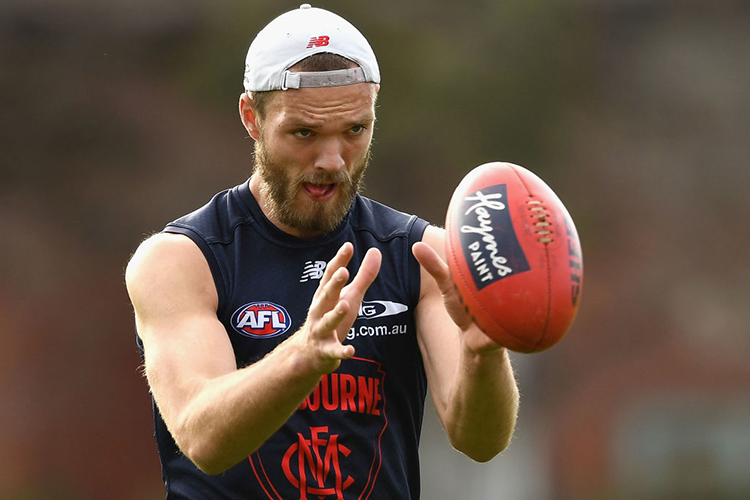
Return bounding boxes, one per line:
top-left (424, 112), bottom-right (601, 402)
top-left (141, 182), bottom-right (427, 500)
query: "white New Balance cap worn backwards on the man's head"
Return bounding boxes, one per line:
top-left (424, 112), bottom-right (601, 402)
top-left (244, 4), bottom-right (380, 92)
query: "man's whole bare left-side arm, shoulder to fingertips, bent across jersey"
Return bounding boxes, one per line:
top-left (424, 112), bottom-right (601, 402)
top-left (125, 234), bottom-right (381, 474)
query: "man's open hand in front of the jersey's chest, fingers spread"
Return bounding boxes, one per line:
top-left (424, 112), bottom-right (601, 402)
top-left (300, 242), bottom-right (382, 373)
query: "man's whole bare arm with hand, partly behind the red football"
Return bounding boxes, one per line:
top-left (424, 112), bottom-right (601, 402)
top-left (412, 226), bottom-right (519, 462)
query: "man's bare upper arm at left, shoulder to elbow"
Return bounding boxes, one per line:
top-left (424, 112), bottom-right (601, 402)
top-left (126, 234), bottom-right (236, 423)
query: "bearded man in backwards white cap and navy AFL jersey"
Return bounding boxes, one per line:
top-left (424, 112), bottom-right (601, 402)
top-left (126, 5), bottom-right (518, 500)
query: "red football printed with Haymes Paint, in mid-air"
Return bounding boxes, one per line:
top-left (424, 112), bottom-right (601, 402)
top-left (445, 162), bottom-right (583, 353)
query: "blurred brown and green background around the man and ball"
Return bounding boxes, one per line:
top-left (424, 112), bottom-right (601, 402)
top-left (0, 0), bottom-right (750, 500)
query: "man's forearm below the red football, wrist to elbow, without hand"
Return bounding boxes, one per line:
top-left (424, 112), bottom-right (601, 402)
top-left (444, 343), bottom-right (519, 462)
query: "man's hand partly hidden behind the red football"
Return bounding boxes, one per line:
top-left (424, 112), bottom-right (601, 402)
top-left (412, 241), bottom-right (501, 353)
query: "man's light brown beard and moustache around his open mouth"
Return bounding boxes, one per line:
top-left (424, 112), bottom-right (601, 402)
top-left (254, 135), bottom-right (370, 235)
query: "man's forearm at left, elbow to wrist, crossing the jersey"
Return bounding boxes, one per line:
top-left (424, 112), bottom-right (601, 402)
top-left (155, 337), bottom-right (323, 474)
